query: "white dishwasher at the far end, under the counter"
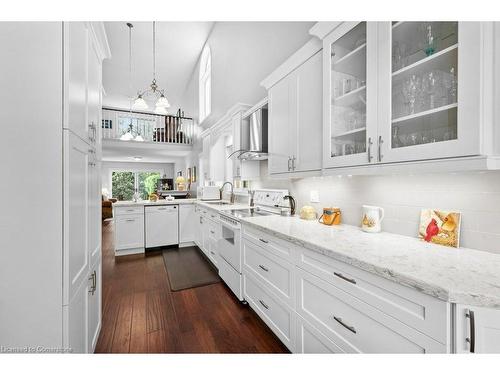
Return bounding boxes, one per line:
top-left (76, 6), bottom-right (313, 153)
top-left (145, 205), bottom-right (179, 248)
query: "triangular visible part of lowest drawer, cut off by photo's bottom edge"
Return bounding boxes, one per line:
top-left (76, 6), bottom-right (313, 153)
top-left (295, 316), bottom-right (345, 354)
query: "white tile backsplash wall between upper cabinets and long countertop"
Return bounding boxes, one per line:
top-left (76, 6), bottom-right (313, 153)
top-left (254, 166), bottom-right (500, 254)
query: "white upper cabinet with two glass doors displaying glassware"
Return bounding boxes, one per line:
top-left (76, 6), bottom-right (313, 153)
top-left (316, 22), bottom-right (498, 169)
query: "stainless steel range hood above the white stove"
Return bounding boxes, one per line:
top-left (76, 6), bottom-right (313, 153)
top-left (238, 108), bottom-right (268, 160)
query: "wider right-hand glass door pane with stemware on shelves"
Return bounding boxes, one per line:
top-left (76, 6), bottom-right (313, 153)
top-left (390, 22), bottom-right (459, 149)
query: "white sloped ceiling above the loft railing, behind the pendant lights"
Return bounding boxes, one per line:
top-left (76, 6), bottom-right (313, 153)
top-left (103, 22), bottom-right (214, 113)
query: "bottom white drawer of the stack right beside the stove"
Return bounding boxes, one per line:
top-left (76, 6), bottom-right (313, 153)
top-left (243, 274), bottom-right (295, 351)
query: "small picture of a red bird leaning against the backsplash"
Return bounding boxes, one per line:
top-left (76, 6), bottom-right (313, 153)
top-left (419, 209), bottom-right (460, 247)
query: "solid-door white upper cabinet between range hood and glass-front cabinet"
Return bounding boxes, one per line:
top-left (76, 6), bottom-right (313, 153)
top-left (262, 40), bottom-right (322, 175)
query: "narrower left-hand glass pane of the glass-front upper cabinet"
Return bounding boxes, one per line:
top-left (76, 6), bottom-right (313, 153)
top-left (330, 22), bottom-right (367, 158)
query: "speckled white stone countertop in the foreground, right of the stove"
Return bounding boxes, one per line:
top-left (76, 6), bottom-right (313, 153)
top-left (241, 216), bottom-right (500, 308)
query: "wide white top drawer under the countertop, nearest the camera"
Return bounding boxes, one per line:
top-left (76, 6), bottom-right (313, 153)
top-left (298, 249), bottom-right (449, 344)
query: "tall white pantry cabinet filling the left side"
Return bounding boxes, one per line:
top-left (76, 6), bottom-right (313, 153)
top-left (0, 22), bottom-right (110, 353)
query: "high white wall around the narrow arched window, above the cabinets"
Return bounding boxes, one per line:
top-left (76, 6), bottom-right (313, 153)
top-left (182, 22), bottom-right (314, 189)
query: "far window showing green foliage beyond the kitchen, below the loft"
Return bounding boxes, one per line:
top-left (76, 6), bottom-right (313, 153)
top-left (111, 171), bottom-right (160, 201)
